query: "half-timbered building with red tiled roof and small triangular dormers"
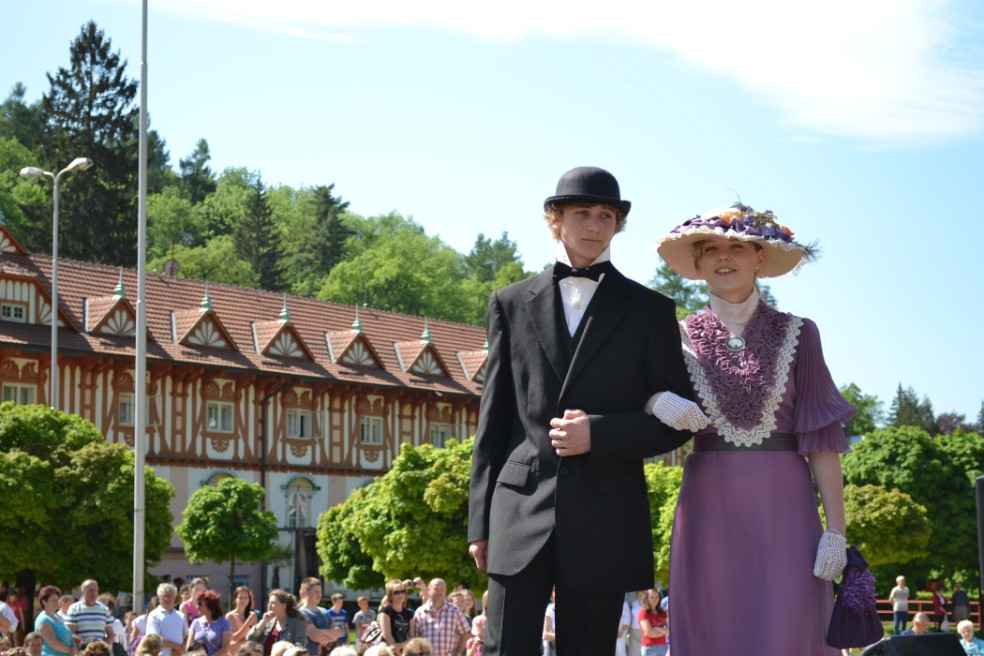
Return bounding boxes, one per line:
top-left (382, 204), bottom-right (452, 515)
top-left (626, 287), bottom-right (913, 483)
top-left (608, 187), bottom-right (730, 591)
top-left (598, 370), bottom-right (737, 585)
top-left (0, 223), bottom-right (487, 591)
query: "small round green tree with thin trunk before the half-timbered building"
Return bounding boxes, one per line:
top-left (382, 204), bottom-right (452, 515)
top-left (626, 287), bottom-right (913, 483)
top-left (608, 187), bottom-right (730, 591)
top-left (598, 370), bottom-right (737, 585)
top-left (175, 478), bottom-right (277, 596)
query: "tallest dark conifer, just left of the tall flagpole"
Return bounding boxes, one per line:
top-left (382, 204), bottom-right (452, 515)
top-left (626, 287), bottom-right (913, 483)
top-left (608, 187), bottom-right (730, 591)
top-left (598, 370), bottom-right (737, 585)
top-left (27, 21), bottom-right (138, 266)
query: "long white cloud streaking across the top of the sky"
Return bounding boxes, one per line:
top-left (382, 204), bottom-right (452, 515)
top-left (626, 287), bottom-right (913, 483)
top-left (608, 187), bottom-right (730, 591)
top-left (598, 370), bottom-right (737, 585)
top-left (155, 0), bottom-right (984, 143)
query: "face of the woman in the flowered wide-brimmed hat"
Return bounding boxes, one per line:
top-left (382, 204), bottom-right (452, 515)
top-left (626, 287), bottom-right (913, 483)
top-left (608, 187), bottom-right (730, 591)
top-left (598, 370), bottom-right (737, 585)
top-left (697, 237), bottom-right (765, 303)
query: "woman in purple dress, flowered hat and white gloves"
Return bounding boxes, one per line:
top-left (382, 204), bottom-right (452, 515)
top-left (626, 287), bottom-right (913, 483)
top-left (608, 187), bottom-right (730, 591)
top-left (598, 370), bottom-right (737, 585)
top-left (646, 203), bottom-right (855, 656)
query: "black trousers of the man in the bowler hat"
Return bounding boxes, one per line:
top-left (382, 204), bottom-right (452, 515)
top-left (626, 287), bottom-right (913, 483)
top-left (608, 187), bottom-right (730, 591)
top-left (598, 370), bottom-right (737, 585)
top-left (482, 537), bottom-right (625, 656)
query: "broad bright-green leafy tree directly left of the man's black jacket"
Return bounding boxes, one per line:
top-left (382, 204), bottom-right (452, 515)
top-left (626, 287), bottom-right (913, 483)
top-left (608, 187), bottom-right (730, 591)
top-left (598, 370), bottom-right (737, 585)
top-left (318, 439), bottom-right (486, 589)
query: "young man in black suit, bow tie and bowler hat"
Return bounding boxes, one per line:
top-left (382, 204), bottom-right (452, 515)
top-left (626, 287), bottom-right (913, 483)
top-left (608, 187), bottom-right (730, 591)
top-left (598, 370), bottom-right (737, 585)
top-left (468, 167), bottom-right (692, 656)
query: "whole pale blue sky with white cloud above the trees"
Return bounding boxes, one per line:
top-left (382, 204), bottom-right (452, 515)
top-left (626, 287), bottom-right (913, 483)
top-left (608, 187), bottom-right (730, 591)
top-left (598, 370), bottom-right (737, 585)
top-left (0, 0), bottom-right (984, 421)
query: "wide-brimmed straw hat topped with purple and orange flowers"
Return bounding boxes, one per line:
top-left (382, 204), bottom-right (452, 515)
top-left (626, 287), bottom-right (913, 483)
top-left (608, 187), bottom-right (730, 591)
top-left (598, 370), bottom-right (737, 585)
top-left (656, 203), bottom-right (817, 280)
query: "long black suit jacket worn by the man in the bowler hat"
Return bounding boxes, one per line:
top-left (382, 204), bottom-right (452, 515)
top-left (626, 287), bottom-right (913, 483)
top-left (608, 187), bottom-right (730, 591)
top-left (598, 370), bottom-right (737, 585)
top-left (468, 269), bottom-right (692, 593)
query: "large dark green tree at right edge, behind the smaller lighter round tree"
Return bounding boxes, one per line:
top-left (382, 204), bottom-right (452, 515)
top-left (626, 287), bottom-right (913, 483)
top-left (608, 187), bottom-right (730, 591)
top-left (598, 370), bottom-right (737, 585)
top-left (843, 426), bottom-right (984, 579)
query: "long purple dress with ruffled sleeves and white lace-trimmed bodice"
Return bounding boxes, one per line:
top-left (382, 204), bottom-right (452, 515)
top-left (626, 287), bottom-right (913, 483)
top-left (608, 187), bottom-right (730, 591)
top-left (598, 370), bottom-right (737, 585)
top-left (670, 303), bottom-right (854, 656)
